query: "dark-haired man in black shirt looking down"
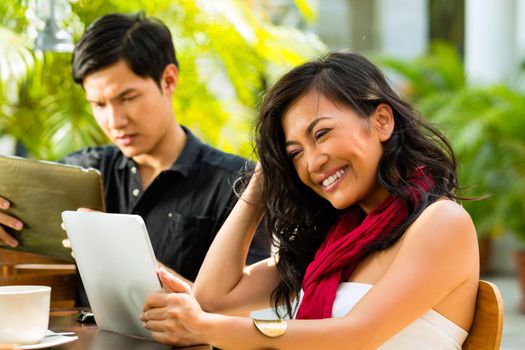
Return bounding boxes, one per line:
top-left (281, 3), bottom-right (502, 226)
top-left (0, 14), bottom-right (268, 304)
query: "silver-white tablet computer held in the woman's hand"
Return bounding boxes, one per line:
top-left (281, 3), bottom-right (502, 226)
top-left (62, 211), bottom-right (161, 338)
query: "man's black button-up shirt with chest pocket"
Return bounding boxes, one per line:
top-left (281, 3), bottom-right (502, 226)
top-left (63, 128), bottom-right (269, 281)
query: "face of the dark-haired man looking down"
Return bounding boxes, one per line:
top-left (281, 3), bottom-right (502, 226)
top-left (83, 60), bottom-right (177, 158)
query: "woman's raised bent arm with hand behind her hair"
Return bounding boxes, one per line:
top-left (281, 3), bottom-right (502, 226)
top-left (193, 170), bottom-right (279, 314)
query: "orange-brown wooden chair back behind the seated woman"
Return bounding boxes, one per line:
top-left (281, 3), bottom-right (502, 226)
top-left (463, 280), bottom-right (503, 350)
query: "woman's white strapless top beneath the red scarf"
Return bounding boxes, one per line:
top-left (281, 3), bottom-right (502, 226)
top-left (299, 282), bottom-right (468, 350)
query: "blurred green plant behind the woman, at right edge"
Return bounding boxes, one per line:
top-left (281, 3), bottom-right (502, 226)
top-left (376, 42), bottom-right (525, 242)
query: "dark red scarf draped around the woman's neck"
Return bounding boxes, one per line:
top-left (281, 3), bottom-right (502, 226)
top-left (296, 168), bottom-right (433, 319)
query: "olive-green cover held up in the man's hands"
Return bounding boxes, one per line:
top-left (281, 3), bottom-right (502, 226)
top-left (0, 156), bottom-right (105, 262)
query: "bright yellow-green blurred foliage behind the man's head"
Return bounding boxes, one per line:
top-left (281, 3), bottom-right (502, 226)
top-left (0, 0), bottom-right (325, 160)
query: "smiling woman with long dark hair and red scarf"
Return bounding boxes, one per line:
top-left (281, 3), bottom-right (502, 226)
top-left (141, 53), bottom-right (479, 349)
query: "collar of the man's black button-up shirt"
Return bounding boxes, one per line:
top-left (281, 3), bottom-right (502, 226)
top-left (117, 126), bottom-right (203, 177)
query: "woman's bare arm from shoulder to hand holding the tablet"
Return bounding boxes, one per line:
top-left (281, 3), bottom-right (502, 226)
top-left (142, 201), bottom-right (478, 350)
